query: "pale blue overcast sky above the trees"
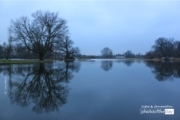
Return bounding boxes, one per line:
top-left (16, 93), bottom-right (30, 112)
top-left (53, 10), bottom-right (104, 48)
top-left (0, 0), bottom-right (180, 55)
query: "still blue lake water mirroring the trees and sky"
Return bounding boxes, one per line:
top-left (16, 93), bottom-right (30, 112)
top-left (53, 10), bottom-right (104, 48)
top-left (0, 60), bottom-right (180, 120)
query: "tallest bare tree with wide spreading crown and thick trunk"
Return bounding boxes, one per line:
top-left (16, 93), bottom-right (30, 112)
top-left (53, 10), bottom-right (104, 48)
top-left (9, 11), bottom-right (68, 60)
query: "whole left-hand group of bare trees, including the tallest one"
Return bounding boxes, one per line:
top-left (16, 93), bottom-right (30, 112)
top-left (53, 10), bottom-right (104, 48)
top-left (1, 11), bottom-right (80, 60)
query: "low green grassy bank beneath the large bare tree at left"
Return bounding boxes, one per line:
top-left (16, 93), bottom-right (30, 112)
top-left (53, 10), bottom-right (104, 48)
top-left (0, 59), bottom-right (52, 64)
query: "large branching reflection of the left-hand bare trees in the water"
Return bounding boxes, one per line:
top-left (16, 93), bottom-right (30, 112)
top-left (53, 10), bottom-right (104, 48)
top-left (0, 62), bottom-right (80, 113)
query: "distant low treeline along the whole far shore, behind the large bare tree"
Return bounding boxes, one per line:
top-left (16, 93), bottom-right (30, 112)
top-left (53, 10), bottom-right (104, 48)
top-left (0, 37), bottom-right (180, 59)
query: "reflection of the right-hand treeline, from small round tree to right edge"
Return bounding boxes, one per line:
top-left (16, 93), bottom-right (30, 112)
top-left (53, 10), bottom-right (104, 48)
top-left (101, 60), bottom-right (180, 81)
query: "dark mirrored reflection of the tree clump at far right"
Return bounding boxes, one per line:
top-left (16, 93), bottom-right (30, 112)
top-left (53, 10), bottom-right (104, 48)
top-left (145, 61), bottom-right (180, 81)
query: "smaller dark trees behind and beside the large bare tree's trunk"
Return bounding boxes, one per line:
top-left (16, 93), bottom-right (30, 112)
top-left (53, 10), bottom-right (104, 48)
top-left (0, 39), bottom-right (80, 59)
